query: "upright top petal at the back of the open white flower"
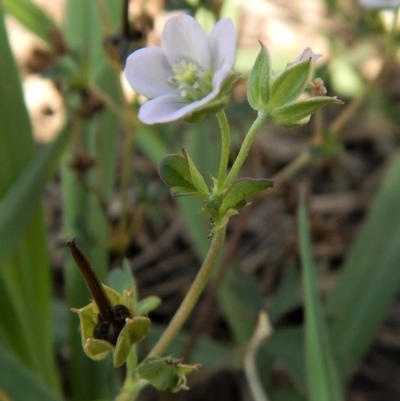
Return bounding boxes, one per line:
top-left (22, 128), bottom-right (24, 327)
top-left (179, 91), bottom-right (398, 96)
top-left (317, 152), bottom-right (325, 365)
top-left (161, 14), bottom-right (211, 70)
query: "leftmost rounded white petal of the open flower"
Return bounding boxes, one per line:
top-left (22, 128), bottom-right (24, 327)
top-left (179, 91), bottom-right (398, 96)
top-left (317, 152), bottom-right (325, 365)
top-left (124, 47), bottom-right (176, 98)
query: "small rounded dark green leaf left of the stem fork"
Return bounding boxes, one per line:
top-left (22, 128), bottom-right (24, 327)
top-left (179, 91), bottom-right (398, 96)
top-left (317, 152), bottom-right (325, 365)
top-left (158, 155), bottom-right (198, 194)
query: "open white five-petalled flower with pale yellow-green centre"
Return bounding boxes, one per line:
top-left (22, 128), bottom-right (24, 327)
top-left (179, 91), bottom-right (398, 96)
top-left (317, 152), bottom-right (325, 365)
top-left (125, 14), bottom-right (236, 124)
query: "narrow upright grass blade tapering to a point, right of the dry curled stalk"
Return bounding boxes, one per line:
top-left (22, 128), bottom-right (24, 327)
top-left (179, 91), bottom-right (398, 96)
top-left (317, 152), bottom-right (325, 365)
top-left (298, 198), bottom-right (344, 401)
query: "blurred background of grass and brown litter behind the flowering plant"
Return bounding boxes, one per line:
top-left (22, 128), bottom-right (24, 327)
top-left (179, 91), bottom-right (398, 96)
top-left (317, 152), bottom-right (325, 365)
top-left (0, 0), bottom-right (400, 401)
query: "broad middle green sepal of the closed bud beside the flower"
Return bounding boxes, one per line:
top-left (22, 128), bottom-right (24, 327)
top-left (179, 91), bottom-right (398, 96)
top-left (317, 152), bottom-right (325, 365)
top-left (268, 60), bottom-right (311, 111)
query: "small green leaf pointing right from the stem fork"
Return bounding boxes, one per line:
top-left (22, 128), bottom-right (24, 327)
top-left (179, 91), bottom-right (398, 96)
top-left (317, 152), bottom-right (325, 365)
top-left (220, 178), bottom-right (274, 216)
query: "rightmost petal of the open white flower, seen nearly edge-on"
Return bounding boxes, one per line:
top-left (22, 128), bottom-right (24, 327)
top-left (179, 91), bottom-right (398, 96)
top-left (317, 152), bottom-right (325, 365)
top-left (209, 18), bottom-right (236, 88)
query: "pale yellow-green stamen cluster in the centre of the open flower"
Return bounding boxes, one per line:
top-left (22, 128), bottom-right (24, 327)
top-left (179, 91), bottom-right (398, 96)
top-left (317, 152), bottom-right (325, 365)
top-left (167, 60), bottom-right (212, 102)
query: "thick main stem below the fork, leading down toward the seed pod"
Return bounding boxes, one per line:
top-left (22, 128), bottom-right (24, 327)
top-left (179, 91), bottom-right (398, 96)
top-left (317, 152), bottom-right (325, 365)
top-left (148, 226), bottom-right (226, 357)
